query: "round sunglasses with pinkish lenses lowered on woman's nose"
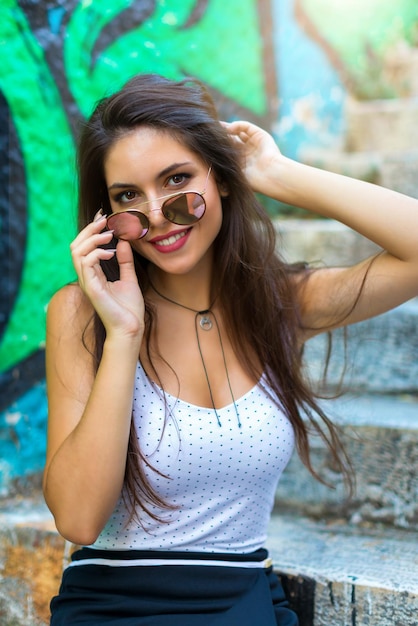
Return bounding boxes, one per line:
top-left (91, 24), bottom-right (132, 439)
top-left (107, 166), bottom-right (212, 241)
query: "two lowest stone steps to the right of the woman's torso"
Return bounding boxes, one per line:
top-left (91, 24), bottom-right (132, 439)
top-left (269, 382), bottom-right (418, 626)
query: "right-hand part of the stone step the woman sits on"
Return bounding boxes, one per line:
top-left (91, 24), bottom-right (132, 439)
top-left (268, 515), bottom-right (418, 626)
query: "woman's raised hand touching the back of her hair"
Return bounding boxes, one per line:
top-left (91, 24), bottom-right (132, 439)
top-left (222, 121), bottom-right (286, 197)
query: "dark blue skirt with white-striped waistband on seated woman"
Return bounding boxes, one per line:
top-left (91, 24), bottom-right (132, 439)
top-left (50, 548), bottom-right (298, 626)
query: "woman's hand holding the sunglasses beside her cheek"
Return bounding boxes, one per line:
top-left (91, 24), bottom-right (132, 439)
top-left (70, 213), bottom-right (144, 337)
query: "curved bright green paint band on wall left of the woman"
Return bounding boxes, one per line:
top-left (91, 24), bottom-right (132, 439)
top-left (0, 0), bottom-right (75, 371)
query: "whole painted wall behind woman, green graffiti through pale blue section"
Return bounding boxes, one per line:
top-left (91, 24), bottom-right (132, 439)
top-left (0, 0), bottom-right (417, 493)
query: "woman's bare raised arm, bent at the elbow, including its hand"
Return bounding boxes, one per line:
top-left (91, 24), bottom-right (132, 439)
top-left (225, 122), bottom-right (418, 334)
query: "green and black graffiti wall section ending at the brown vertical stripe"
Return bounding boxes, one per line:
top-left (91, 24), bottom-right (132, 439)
top-left (0, 0), bottom-right (277, 491)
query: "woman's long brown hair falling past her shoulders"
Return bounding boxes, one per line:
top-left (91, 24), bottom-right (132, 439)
top-left (78, 75), bottom-right (351, 516)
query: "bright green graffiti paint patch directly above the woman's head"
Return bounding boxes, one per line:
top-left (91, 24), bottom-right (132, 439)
top-left (64, 0), bottom-right (267, 115)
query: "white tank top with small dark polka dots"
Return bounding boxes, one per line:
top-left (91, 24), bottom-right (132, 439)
top-left (92, 364), bottom-right (294, 553)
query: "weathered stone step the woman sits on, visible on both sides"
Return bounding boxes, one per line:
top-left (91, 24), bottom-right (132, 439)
top-left (0, 500), bottom-right (418, 626)
